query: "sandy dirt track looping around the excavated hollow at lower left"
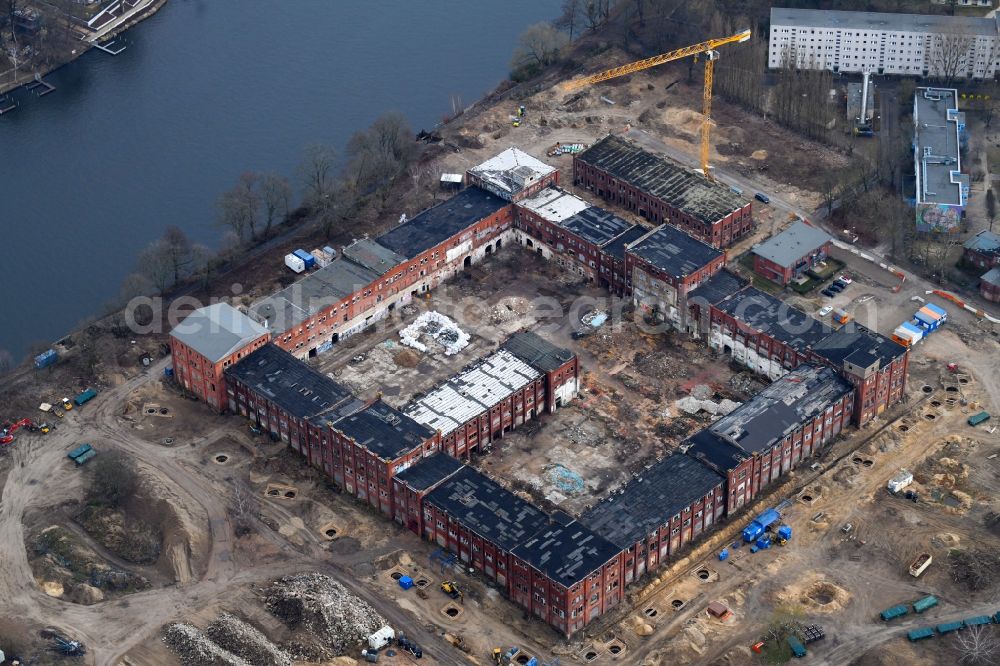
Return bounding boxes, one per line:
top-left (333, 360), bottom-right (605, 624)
top-left (0, 360), bottom-right (468, 666)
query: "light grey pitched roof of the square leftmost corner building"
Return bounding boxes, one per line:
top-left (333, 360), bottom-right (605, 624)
top-left (170, 303), bottom-right (267, 363)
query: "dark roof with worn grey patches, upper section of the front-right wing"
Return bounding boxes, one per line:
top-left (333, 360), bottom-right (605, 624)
top-left (708, 363), bottom-right (853, 453)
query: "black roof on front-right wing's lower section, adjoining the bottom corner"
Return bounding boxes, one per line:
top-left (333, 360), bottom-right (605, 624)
top-left (580, 454), bottom-right (723, 549)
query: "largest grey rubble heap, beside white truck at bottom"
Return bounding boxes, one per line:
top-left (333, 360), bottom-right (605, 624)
top-left (264, 574), bottom-right (388, 655)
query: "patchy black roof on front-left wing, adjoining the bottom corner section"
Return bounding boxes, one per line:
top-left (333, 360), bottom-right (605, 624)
top-left (424, 466), bottom-right (548, 551)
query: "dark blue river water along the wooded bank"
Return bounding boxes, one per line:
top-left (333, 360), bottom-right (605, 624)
top-left (0, 0), bottom-right (559, 358)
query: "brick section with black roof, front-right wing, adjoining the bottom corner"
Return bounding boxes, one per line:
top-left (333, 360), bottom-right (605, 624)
top-left (580, 454), bottom-right (726, 585)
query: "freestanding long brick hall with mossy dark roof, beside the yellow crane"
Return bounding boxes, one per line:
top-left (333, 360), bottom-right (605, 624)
top-left (573, 135), bottom-right (753, 248)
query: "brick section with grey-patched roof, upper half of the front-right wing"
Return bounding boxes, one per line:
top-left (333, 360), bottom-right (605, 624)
top-left (683, 365), bottom-right (854, 514)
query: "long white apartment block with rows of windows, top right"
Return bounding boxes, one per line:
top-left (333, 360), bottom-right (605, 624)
top-left (767, 8), bottom-right (1000, 79)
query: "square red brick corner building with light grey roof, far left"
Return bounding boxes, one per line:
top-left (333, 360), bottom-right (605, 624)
top-left (170, 303), bottom-right (271, 411)
